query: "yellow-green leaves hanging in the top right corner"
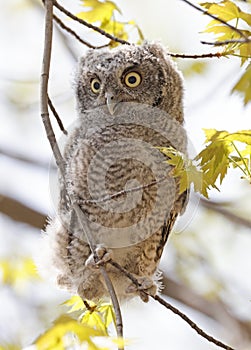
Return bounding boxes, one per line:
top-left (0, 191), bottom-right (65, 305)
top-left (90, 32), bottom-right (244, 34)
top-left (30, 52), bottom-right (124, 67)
top-left (201, 0), bottom-right (251, 105)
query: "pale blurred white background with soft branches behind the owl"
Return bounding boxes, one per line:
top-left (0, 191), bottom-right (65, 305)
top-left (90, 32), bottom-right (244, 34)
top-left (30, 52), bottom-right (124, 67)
top-left (0, 0), bottom-right (251, 350)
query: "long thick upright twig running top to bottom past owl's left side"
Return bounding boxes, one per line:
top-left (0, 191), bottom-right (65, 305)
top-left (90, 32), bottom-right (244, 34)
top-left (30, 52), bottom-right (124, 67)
top-left (41, 0), bottom-right (123, 350)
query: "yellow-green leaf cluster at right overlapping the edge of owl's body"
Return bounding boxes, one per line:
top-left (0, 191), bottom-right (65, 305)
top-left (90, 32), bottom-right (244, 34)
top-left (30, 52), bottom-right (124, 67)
top-left (160, 129), bottom-right (251, 198)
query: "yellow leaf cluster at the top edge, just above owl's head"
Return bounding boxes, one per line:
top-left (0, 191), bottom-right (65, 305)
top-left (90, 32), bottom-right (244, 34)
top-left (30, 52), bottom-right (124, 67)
top-left (77, 0), bottom-right (144, 47)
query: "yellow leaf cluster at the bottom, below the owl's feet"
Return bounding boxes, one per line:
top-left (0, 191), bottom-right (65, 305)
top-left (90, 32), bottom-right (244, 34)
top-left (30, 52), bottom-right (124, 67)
top-left (34, 296), bottom-right (124, 350)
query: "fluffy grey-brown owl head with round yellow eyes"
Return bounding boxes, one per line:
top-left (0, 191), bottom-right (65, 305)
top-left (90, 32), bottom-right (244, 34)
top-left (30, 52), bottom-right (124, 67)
top-left (75, 42), bottom-right (183, 123)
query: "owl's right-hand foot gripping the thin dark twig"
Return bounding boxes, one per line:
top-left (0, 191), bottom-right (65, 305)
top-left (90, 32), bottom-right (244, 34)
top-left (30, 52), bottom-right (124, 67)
top-left (126, 276), bottom-right (157, 303)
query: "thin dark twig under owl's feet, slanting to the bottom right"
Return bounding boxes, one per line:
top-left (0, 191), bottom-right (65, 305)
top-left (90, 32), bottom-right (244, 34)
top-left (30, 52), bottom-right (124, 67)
top-left (108, 260), bottom-right (234, 350)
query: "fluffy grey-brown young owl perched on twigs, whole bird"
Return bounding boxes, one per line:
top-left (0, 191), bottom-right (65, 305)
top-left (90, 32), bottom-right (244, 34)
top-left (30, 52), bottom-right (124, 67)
top-left (46, 42), bottom-right (187, 301)
